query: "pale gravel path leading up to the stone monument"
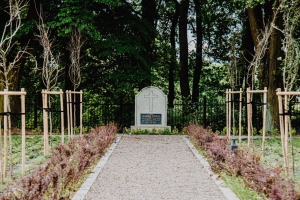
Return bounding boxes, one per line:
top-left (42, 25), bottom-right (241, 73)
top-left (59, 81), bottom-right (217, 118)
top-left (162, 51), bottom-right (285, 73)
top-left (85, 135), bottom-right (227, 200)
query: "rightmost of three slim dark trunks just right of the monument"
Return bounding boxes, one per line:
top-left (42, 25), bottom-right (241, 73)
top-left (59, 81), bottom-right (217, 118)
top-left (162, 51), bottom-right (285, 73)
top-left (192, 0), bottom-right (202, 106)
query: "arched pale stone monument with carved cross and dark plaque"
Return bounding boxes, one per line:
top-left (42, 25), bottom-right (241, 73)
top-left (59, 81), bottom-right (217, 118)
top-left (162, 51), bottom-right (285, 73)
top-left (131, 86), bottom-right (171, 132)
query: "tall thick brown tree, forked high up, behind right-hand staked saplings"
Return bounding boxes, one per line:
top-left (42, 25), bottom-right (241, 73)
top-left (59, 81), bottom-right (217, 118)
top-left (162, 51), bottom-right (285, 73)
top-left (247, 0), bottom-right (283, 131)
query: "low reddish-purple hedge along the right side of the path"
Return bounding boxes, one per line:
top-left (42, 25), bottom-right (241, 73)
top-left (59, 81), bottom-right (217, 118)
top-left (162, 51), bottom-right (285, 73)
top-left (184, 124), bottom-right (300, 200)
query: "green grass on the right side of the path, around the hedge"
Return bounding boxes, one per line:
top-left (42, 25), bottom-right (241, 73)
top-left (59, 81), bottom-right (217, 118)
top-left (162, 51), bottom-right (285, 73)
top-left (192, 134), bottom-right (300, 200)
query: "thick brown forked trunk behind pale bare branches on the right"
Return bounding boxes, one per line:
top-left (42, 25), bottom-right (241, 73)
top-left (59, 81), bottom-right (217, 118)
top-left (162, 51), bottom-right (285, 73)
top-left (247, 0), bottom-right (282, 131)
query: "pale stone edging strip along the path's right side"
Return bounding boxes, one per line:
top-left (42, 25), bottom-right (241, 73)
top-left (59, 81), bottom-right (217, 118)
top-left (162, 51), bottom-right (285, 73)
top-left (182, 136), bottom-right (239, 200)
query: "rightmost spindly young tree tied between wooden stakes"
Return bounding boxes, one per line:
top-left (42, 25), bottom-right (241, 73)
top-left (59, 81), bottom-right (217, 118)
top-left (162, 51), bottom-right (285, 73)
top-left (275, 0), bottom-right (300, 175)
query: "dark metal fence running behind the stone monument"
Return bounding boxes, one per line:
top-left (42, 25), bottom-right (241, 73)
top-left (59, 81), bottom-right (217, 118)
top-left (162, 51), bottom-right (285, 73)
top-left (15, 93), bottom-right (300, 133)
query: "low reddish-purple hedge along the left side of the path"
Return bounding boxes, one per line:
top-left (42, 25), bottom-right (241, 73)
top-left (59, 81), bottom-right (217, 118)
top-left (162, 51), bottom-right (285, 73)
top-left (0, 124), bottom-right (117, 200)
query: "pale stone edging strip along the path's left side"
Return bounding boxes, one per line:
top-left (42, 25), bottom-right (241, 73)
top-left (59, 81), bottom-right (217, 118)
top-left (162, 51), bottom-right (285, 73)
top-left (72, 136), bottom-right (122, 200)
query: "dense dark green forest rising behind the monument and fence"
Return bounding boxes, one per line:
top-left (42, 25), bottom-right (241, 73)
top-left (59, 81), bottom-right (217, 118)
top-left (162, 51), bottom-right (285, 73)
top-left (0, 0), bottom-right (300, 131)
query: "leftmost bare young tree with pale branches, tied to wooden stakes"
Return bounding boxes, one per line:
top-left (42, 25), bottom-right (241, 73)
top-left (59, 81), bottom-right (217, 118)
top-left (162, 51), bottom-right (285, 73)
top-left (0, 0), bottom-right (35, 178)
